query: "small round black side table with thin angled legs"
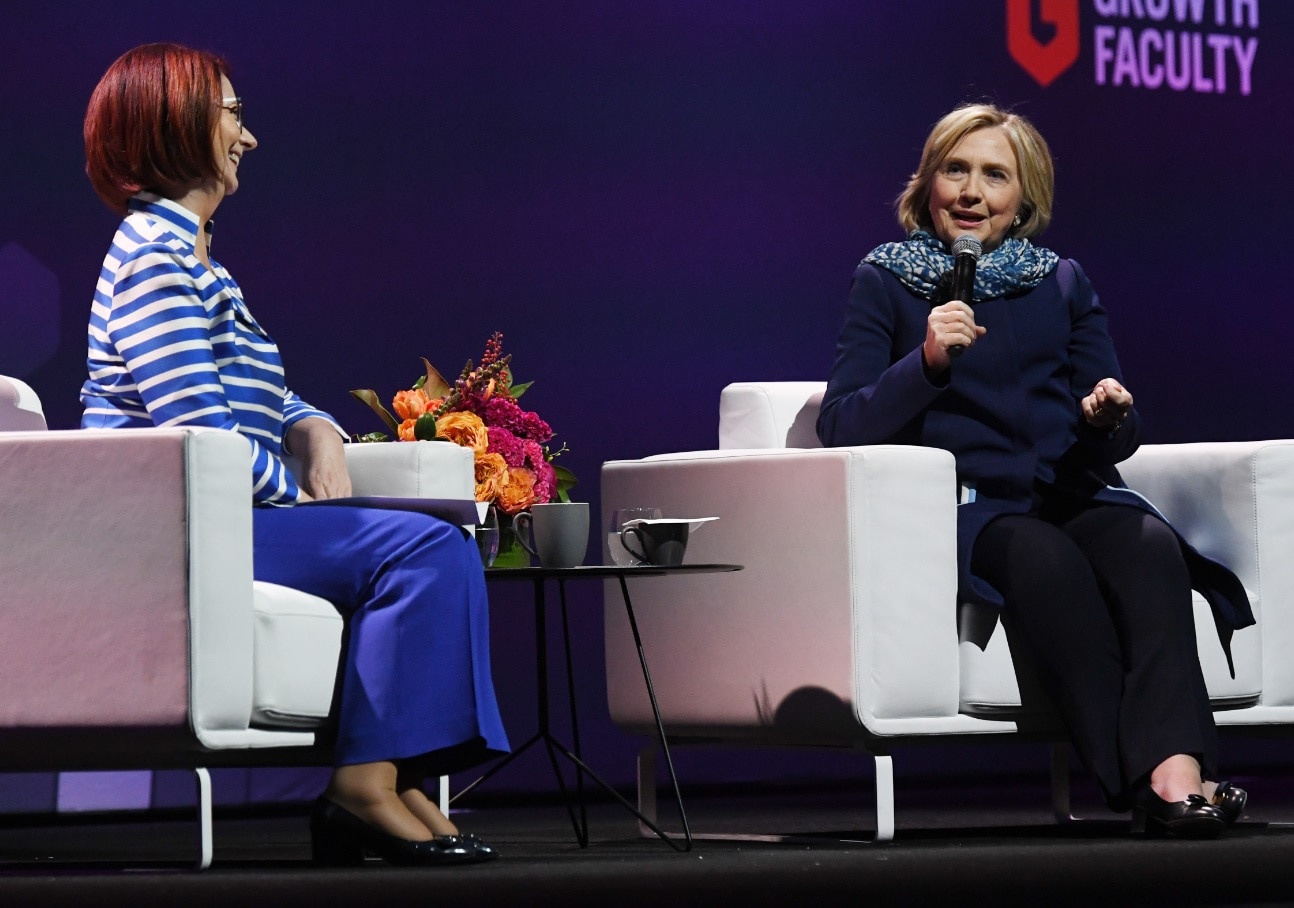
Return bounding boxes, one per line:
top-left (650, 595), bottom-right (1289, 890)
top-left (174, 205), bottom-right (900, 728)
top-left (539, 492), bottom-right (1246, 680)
top-left (450, 564), bottom-right (743, 851)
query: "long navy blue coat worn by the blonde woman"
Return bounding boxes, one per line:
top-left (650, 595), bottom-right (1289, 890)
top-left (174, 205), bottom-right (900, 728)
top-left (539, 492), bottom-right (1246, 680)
top-left (818, 259), bottom-right (1254, 657)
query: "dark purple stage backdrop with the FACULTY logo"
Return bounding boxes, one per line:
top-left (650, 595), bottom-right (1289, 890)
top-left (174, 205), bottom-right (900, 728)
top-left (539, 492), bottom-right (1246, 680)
top-left (0, 0), bottom-right (1294, 810)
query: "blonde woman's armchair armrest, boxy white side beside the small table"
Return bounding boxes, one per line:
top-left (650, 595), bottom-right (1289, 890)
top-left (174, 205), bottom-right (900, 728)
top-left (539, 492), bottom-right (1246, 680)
top-left (602, 445), bottom-right (958, 744)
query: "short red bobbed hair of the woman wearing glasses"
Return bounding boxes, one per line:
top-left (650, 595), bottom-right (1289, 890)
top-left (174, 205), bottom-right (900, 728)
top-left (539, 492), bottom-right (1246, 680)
top-left (84, 44), bottom-right (229, 212)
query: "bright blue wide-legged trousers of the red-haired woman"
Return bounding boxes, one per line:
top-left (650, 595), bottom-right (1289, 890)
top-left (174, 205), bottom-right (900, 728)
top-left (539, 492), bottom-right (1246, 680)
top-left (254, 506), bottom-right (509, 772)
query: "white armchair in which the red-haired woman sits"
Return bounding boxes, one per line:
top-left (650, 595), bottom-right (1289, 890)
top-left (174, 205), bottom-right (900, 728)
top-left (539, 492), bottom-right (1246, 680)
top-left (0, 376), bottom-right (474, 867)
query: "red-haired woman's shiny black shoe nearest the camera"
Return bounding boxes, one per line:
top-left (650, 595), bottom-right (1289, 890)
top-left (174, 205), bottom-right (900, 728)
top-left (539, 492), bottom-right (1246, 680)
top-left (311, 798), bottom-right (498, 867)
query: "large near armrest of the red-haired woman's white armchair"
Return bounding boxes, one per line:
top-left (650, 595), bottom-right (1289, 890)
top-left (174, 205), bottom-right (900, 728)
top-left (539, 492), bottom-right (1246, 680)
top-left (0, 429), bottom-right (251, 739)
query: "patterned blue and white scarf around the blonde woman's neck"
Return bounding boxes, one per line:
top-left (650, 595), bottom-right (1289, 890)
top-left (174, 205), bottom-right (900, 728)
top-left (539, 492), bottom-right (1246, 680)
top-left (863, 230), bottom-right (1060, 300)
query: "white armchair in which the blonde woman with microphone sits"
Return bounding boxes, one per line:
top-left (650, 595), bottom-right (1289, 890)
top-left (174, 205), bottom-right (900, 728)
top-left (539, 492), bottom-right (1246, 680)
top-left (602, 383), bottom-right (1294, 841)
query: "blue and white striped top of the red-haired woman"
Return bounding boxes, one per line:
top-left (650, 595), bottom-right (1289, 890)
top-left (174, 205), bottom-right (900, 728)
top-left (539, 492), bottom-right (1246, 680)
top-left (82, 193), bottom-right (344, 504)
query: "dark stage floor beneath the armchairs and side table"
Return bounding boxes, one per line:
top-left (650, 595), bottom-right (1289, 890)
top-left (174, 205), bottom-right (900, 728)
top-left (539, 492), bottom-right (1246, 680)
top-left (0, 779), bottom-right (1294, 908)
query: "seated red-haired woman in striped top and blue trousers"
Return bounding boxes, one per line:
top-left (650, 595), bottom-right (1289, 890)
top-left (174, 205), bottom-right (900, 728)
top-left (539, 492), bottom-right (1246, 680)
top-left (82, 44), bottom-right (507, 865)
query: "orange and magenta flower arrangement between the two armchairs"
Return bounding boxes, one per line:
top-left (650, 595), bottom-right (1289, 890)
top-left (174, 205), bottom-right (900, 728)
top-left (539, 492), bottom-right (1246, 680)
top-left (351, 331), bottom-right (576, 516)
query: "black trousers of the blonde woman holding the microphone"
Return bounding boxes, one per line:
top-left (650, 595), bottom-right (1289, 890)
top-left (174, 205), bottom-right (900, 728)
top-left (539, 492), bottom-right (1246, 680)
top-left (971, 504), bottom-right (1218, 810)
